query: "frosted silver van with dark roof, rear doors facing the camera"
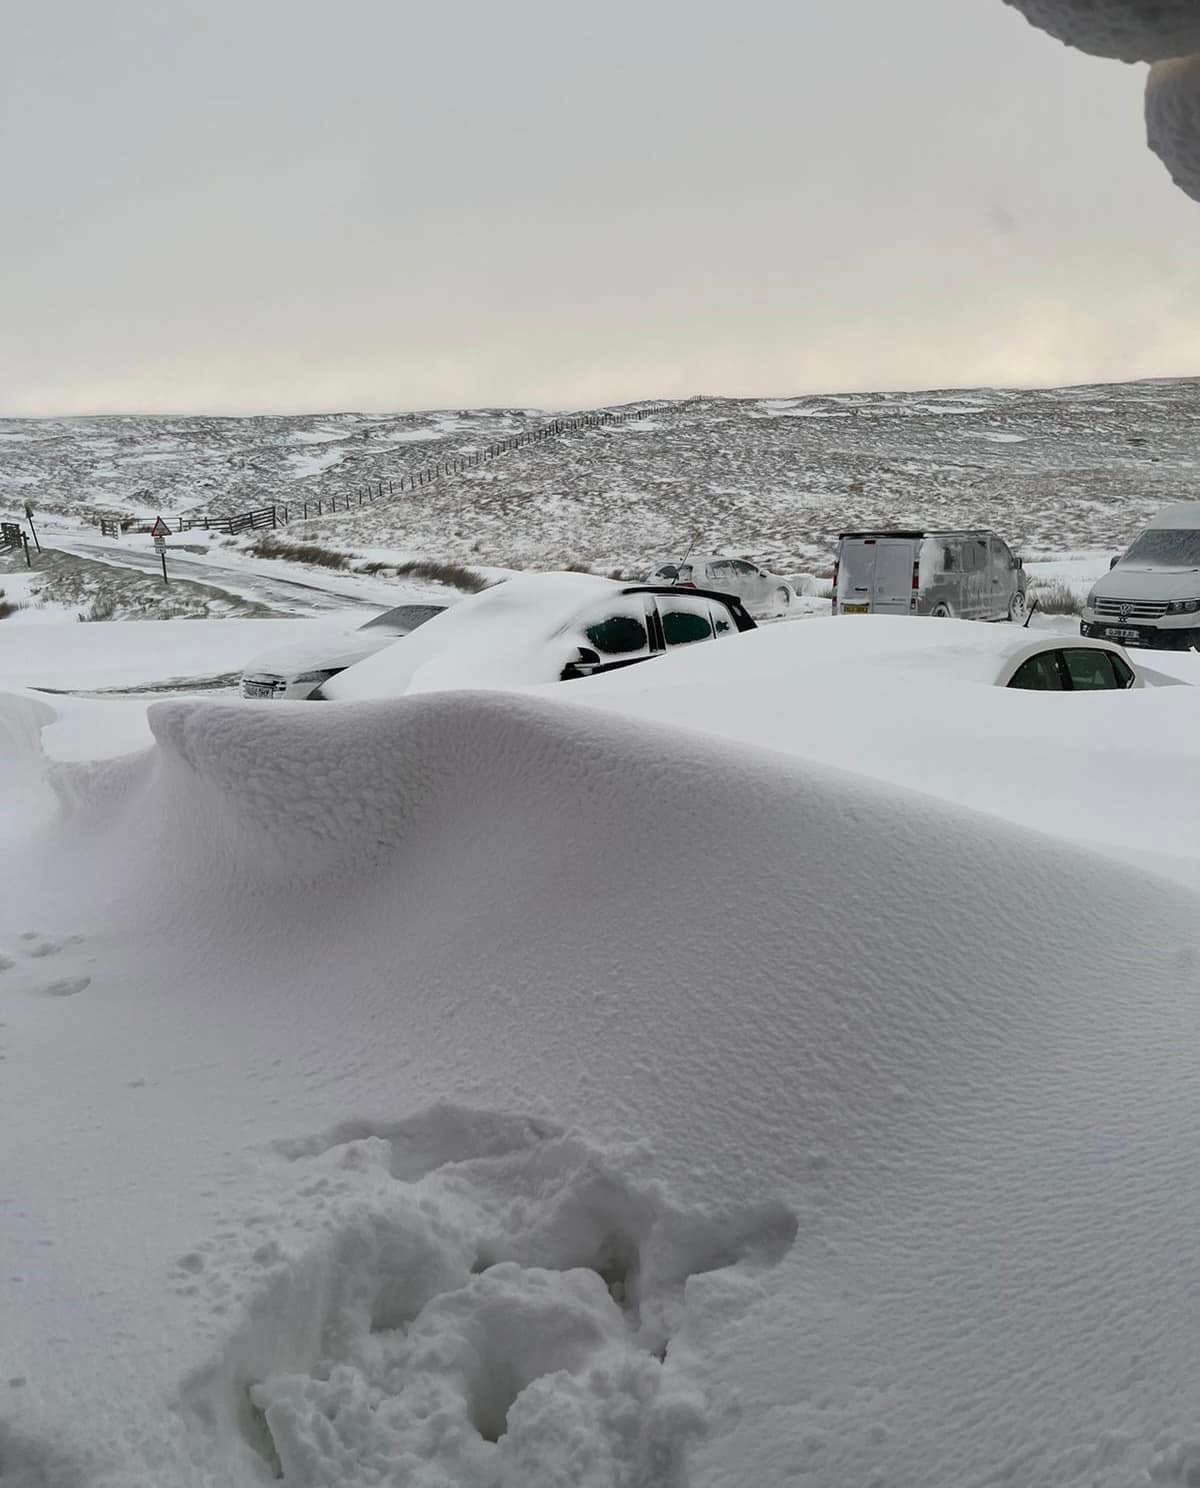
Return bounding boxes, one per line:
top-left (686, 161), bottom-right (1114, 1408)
top-left (834, 527), bottom-right (1026, 623)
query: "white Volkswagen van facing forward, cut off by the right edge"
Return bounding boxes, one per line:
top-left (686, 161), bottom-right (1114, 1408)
top-left (1079, 501), bottom-right (1200, 650)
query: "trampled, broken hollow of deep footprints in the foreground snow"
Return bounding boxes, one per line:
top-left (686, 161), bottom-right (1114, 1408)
top-left (177, 1106), bottom-right (797, 1488)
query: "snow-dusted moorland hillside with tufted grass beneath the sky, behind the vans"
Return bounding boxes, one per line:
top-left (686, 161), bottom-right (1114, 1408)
top-left (0, 381), bottom-right (1200, 571)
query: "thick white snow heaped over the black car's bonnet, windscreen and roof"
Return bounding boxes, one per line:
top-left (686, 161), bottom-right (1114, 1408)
top-left (323, 573), bottom-right (625, 699)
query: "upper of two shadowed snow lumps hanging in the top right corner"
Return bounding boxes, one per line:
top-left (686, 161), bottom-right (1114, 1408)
top-left (1005, 0), bottom-right (1200, 62)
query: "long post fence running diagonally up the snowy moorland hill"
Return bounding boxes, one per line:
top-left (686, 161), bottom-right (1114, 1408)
top-left (100, 394), bottom-right (703, 537)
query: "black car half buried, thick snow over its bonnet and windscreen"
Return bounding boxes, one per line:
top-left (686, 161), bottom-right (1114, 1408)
top-left (320, 573), bottom-right (755, 699)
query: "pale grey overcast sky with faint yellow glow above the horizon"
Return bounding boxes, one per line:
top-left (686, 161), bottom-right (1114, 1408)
top-left (0, 0), bottom-right (1200, 414)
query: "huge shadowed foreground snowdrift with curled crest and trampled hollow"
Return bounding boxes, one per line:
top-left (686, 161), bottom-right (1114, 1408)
top-left (0, 678), bottom-right (1200, 1488)
